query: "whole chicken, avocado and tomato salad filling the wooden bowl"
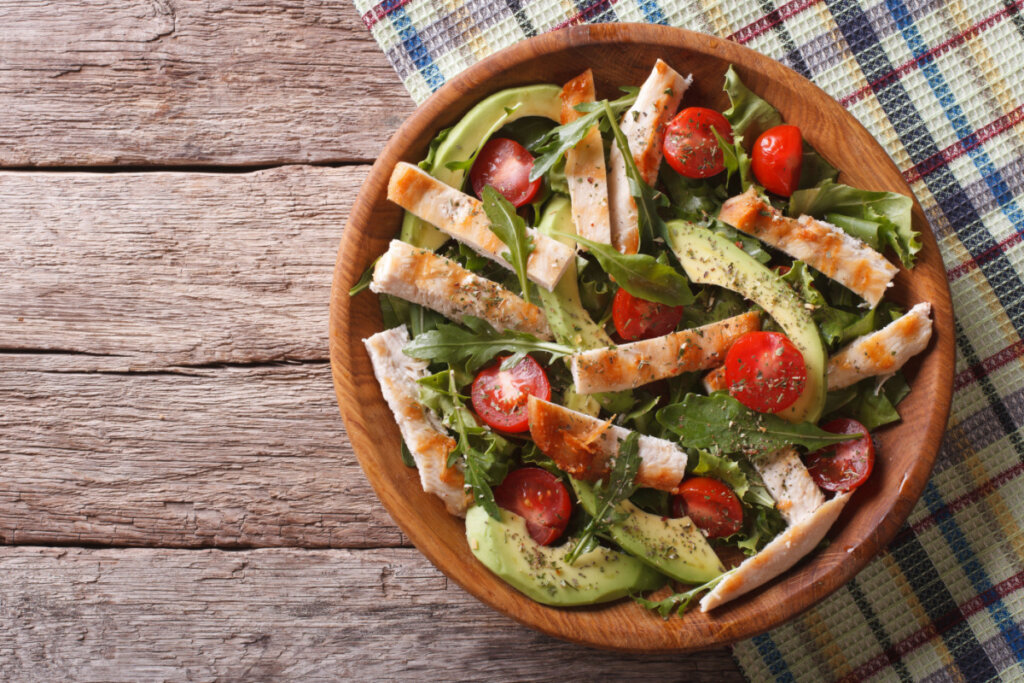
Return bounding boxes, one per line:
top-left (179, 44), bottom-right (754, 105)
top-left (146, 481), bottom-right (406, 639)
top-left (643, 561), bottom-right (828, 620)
top-left (351, 61), bottom-right (931, 616)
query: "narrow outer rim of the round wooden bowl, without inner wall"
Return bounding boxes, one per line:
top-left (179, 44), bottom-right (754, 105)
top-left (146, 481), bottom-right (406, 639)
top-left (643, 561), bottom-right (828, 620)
top-left (330, 24), bottom-right (954, 652)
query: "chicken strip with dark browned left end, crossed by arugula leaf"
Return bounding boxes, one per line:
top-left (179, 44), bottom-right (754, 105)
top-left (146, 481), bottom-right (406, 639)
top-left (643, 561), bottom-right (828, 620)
top-left (526, 396), bottom-right (686, 492)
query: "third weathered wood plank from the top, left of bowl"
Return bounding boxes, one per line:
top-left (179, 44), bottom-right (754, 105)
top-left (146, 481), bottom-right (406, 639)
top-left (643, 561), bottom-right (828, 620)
top-left (0, 354), bottom-right (408, 548)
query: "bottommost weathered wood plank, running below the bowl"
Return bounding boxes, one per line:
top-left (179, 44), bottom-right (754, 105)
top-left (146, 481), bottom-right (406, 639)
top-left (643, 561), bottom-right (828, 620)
top-left (0, 548), bottom-right (742, 683)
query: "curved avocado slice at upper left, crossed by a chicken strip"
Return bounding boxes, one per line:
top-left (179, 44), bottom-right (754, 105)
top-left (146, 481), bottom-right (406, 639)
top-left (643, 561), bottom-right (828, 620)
top-left (400, 84), bottom-right (562, 251)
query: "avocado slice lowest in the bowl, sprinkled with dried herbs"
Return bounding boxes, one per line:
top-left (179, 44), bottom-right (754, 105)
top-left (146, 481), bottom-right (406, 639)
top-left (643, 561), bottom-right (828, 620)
top-left (466, 506), bottom-right (665, 607)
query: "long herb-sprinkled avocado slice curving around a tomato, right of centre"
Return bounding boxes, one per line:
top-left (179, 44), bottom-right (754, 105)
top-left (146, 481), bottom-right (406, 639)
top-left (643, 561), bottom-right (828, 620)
top-left (666, 220), bottom-right (826, 422)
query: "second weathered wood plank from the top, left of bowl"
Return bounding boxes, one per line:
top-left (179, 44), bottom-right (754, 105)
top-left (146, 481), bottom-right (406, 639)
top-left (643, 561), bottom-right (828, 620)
top-left (0, 165), bottom-right (356, 370)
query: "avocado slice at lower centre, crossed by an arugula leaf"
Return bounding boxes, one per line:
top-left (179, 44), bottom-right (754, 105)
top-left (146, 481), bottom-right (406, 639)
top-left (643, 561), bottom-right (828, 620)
top-left (570, 477), bottom-right (725, 584)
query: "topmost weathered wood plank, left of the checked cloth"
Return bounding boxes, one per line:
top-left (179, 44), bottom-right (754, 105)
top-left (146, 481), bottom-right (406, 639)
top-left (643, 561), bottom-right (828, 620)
top-left (0, 0), bottom-right (414, 166)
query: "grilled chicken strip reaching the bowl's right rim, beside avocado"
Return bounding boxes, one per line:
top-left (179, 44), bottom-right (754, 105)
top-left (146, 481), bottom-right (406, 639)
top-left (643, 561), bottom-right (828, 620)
top-left (826, 302), bottom-right (932, 391)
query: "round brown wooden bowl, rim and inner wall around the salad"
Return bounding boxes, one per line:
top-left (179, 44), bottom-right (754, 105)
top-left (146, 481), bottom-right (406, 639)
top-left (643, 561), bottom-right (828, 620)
top-left (331, 25), bottom-right (953, 652)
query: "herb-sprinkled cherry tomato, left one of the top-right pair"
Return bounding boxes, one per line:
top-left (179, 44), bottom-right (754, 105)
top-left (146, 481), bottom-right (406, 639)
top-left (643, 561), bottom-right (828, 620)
top-left (662, 106), bottom-right (732, 178)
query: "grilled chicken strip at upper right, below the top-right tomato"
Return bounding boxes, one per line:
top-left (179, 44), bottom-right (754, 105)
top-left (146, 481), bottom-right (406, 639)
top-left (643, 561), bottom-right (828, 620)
top-left (718, 187), bottom-right (899, 308)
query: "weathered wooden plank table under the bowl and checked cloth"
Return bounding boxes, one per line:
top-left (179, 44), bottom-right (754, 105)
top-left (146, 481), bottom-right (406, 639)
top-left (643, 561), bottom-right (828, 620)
top-left (0, 0), bottom-right (741, 683)
